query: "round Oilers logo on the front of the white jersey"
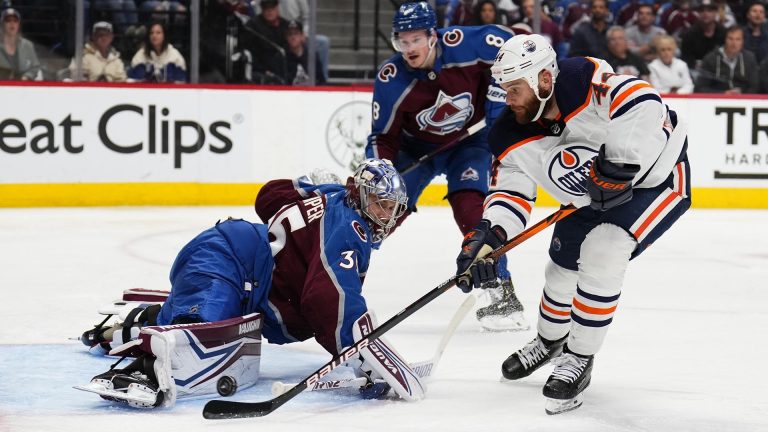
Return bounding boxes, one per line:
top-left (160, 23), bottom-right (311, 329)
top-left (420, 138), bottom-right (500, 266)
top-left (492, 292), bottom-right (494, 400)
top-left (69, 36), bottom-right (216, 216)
top-left (547, 146), bottom-right (597, 196)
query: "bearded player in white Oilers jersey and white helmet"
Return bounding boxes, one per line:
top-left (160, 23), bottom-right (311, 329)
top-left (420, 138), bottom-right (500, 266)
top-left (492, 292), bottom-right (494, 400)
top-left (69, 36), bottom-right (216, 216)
top-left (457, 35), bottom-right (691, 414)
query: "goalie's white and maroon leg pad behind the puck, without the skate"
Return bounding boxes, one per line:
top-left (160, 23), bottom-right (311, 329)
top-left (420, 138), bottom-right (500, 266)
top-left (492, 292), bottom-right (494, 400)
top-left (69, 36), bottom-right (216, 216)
top-left (110, 313), bottom-right (262, 407)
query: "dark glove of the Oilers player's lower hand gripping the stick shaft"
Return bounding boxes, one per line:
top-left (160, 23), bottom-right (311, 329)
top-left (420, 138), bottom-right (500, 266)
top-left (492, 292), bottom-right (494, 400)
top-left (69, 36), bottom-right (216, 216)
top-left (456, 219), bottom-right (507, 293)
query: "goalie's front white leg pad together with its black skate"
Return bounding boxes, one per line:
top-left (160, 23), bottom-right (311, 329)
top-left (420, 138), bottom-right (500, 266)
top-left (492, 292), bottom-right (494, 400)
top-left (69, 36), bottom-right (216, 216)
top-left (75, 313), bottom-right (262, 408)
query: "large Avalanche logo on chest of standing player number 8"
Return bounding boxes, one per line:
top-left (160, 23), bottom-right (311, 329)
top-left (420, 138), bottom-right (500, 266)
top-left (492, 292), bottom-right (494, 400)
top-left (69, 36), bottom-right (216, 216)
top-left (416, 90), bottom-right (475, 135)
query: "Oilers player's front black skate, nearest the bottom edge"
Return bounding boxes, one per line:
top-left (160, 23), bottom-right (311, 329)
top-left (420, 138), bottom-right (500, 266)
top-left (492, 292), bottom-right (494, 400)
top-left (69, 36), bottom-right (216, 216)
top-left (543, 347), bottom-right (595, 415)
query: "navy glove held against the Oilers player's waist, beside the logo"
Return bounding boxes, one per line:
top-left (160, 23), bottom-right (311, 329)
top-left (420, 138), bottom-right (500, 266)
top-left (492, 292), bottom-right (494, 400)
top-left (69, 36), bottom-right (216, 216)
top-left (587, 144), bottom-right (640, 211)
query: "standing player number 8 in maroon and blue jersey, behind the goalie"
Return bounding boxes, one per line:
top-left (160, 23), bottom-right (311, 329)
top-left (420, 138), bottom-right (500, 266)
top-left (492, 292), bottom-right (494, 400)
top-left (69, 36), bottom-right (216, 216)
top-left (366, 1), bottom-right (529, 331)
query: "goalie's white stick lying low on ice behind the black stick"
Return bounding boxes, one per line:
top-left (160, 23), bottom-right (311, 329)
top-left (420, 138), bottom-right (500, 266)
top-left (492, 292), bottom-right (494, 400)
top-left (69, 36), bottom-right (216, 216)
top-left (272, 296), bottom-right (477, 396)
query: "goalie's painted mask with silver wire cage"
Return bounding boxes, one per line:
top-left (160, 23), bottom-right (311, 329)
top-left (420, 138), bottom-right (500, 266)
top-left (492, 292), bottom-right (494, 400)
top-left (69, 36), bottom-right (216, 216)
top-left (347, 159), bottom-right (408, 243)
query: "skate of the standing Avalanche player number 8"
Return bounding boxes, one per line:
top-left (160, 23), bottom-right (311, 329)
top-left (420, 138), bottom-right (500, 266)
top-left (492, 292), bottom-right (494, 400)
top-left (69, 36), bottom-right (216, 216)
top-left (477, 278), bottom-right (530, 331)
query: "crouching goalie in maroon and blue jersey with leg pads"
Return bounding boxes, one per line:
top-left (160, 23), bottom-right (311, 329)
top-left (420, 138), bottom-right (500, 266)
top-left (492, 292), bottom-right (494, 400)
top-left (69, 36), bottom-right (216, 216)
top-left (78, 159), bottom-right (424, 408)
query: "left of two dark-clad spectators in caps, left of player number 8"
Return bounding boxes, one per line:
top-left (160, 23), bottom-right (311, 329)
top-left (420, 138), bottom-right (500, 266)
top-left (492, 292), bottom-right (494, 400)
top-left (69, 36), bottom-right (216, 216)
top-left (243, 0), bottom-right (288, 83)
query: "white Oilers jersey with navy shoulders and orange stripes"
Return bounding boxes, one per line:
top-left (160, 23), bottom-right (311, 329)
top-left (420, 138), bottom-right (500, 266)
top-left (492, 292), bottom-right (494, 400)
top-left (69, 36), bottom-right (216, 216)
top-left (483, 57), bottom-right (685, 237)
